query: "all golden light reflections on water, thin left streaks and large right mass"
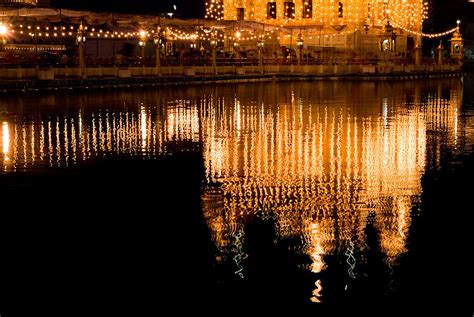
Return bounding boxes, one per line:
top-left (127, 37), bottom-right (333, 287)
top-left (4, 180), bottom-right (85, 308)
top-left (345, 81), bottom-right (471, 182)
top-left (2, 81), bottom-right (470, 274)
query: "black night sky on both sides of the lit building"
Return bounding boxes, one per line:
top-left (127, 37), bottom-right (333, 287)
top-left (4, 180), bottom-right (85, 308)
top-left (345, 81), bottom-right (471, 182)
top-left (52, 0), bottom-right (474, 25)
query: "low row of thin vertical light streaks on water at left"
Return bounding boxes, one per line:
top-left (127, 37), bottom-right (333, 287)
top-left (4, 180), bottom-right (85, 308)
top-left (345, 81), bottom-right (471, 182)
top-left (0, 95), bottom-right (199, 172)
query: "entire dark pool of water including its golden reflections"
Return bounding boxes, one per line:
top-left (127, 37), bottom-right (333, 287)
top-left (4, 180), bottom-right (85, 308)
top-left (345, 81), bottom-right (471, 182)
top-left (0, 77), bottom-right (474, 317)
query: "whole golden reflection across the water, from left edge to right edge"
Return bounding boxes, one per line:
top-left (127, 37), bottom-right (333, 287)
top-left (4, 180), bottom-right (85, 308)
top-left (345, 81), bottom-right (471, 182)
top-left (0, 81), bottom-right (474, 292)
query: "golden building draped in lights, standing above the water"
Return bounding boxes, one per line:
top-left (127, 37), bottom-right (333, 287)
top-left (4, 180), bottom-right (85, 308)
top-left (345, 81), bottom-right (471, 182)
top-left (211, 0), bottom-right (428, 57)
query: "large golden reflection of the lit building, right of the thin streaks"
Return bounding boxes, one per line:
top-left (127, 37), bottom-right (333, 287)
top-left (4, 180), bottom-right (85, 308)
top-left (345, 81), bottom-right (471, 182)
top-left (200, 79), bottom-right (474, 294)
